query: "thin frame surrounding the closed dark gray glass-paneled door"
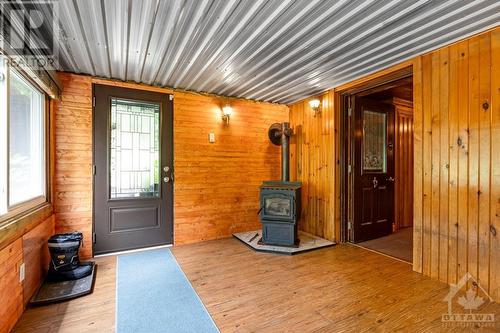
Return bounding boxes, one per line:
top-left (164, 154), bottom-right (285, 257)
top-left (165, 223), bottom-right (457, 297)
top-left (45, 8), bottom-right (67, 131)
top-left (91, 80), bottom-right (175, 256)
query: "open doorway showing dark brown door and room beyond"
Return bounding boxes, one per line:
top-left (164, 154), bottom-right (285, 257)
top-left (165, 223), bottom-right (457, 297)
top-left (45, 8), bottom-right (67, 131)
top-left (341, 68), bottom-right (413, 263)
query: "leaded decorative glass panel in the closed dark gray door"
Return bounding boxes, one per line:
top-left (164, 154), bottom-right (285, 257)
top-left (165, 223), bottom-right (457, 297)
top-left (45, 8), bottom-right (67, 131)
top-left (109, 98), bottom-right (160, 199)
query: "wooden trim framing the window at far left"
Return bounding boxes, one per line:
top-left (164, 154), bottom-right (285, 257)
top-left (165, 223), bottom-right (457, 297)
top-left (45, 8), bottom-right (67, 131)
top-left (0, 60), bottom-right (52, 226)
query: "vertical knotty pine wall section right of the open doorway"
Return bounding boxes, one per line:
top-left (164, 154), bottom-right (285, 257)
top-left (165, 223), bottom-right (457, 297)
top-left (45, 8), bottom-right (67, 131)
top-left (414, 29), bottom-right (500, 300)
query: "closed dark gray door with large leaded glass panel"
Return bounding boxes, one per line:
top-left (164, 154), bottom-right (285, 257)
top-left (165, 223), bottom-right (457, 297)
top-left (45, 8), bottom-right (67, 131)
top-left (93, 84), bottom-right (173, 254)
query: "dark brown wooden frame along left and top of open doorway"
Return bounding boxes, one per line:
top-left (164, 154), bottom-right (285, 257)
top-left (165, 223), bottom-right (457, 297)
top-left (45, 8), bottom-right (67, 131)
top-left (335, 65), bottom-right (413, 243)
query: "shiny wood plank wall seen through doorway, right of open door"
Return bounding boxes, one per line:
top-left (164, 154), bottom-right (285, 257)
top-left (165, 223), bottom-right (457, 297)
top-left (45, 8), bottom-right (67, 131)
top-left (392, 98), bottom-right (413, 229)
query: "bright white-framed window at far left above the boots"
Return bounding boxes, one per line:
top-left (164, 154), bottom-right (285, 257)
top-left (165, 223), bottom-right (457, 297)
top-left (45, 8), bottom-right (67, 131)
top-left (0, 58), bottom-right (47, 220)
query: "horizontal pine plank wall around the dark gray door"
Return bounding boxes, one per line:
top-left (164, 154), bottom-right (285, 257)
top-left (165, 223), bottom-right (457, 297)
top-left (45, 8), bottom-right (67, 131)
top-left (54, 73), bottom-right (288, 257)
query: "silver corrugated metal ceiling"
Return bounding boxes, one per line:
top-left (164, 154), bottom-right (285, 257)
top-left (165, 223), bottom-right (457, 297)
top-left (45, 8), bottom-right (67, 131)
top-left (9, 0), bottom-right (500, 103)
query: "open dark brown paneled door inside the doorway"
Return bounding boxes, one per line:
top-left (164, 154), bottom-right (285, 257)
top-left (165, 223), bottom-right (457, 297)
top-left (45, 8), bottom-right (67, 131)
top-left (351, 97), bottom-right (394, 243)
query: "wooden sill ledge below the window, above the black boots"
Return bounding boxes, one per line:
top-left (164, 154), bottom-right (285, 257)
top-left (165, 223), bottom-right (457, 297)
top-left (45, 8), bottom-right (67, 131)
top-left (0, 202), bottom-right (53, 250)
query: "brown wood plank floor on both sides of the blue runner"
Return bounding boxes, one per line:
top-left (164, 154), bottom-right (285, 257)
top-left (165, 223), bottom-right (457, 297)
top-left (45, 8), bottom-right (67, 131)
top-left (15, 239), bottom-right (500, 332)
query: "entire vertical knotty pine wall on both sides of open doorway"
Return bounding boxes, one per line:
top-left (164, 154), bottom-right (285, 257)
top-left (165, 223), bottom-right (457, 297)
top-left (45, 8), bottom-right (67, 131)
top-left (290, 28), bottom-right (500, 301)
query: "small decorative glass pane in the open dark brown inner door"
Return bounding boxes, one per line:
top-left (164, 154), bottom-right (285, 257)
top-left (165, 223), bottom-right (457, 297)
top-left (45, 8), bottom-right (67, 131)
top-left (363, 110), bottom-right (387, 172)
